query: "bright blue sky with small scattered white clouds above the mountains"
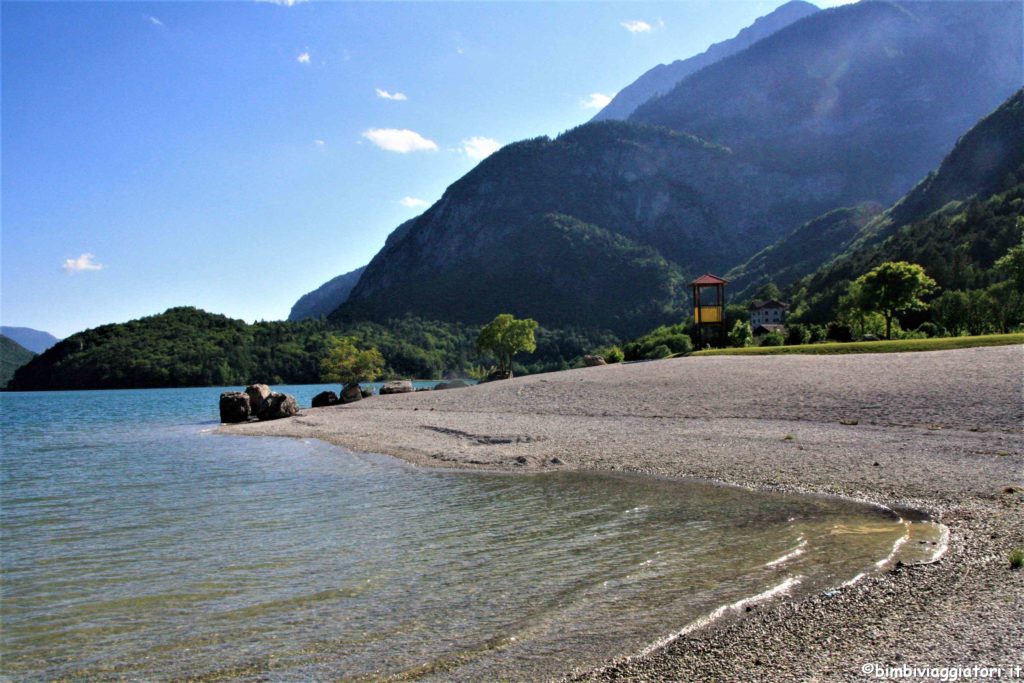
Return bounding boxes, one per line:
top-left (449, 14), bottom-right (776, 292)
top-left (0, 0), bottom-right (856, 337)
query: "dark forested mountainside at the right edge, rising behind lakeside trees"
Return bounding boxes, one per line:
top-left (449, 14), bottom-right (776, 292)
top-left (780, 89), bottom-right (1024, 321)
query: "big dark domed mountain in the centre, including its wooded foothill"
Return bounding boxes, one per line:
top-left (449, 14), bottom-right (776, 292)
top-left (334, 121), bottom-right (864, 336)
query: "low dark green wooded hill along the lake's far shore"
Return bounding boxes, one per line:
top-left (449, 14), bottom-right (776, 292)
top-left (9, 307), bottom-right (618, 390)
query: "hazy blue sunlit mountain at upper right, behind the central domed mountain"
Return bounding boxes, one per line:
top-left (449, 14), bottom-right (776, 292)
top-left (630, 0), bottom-right (1024, 206)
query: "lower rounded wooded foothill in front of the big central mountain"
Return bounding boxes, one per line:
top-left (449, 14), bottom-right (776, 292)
top-left (335, 214), bottom-right (686, 335)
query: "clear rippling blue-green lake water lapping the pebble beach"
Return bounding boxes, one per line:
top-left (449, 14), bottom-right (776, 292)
top-left (0, 386), bottom-right (929, 681)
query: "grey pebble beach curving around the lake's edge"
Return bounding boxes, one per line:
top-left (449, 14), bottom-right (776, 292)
top-left (224, 346), bottom-right (1024, 681)
